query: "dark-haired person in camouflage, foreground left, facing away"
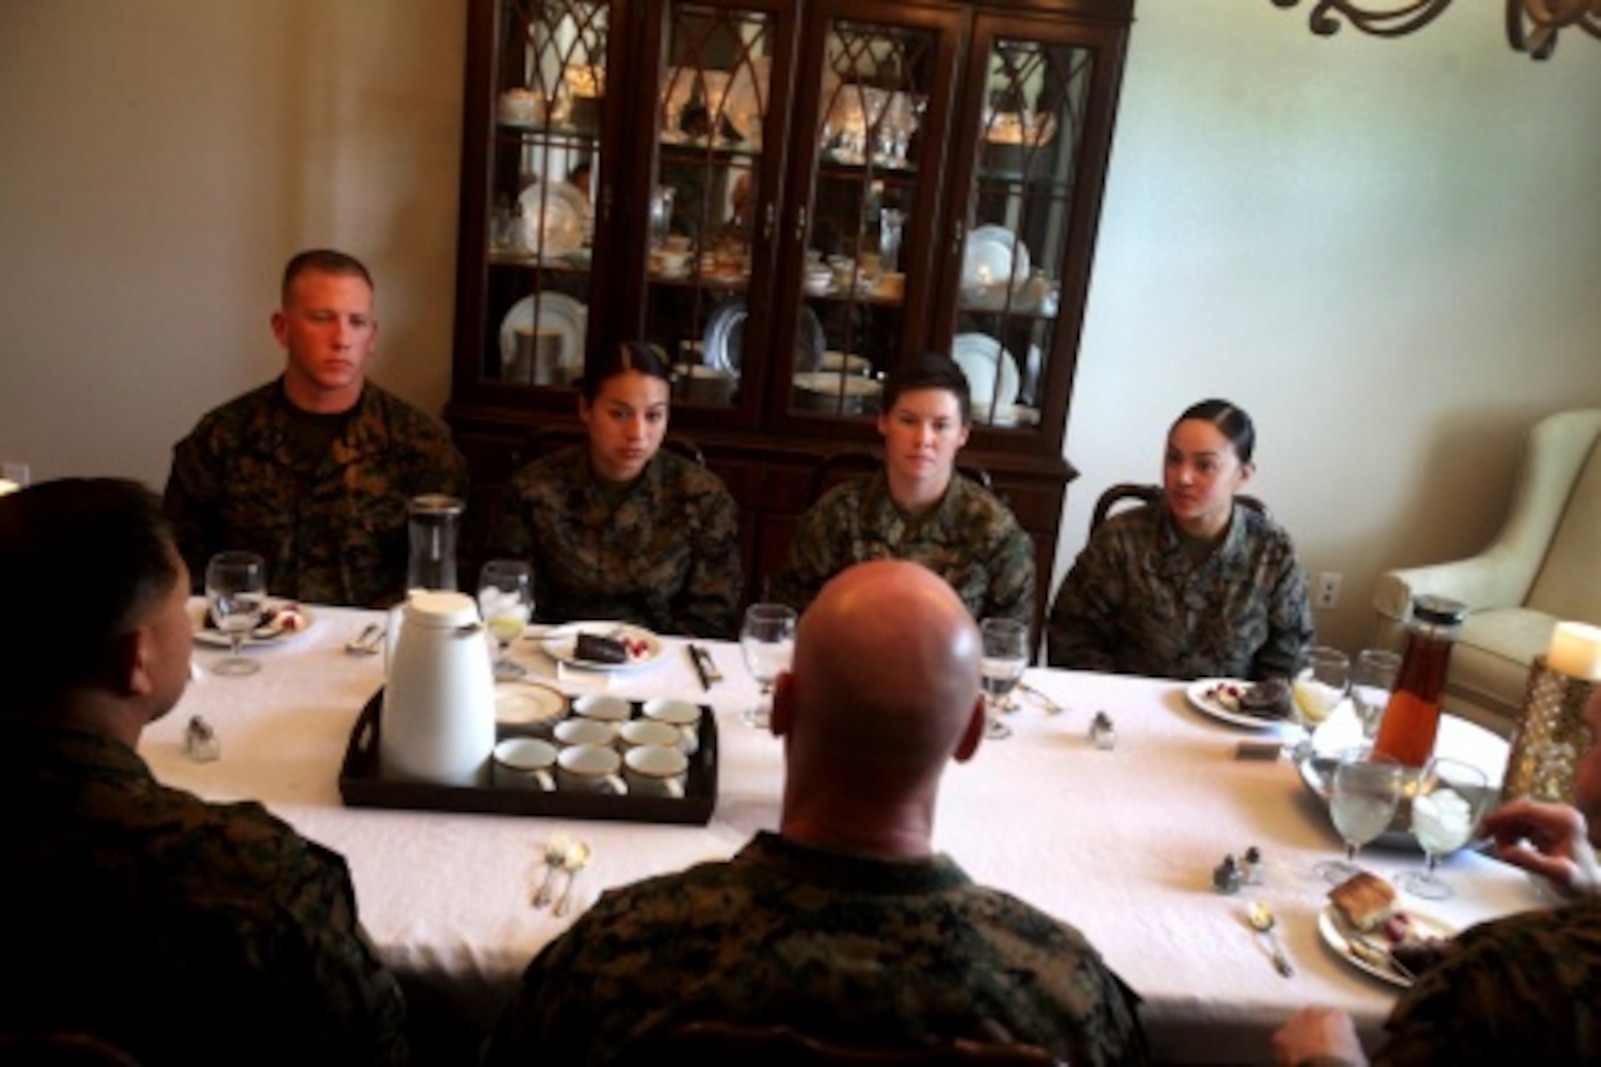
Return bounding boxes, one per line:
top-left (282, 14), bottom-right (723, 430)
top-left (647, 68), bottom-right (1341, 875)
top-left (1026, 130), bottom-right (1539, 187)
top-left (0, 479), bottom-right (407, 1065)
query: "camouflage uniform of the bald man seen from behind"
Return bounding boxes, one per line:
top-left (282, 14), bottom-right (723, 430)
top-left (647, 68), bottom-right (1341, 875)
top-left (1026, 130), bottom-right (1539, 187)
top-left (485, 833), bottom-right (1148, 1067)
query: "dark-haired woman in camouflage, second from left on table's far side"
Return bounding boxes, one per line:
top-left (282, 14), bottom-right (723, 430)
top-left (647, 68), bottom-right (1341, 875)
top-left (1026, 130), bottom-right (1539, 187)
top-left (490, 341), bottom-right (740, 638)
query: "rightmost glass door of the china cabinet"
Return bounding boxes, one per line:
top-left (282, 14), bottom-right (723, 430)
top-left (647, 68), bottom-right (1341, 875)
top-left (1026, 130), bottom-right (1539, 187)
top-left (951, 24), bottom-right (1095, 429)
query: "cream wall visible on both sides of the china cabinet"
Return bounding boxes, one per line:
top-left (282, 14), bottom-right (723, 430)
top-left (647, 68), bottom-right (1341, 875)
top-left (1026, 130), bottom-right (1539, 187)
top-left (0, 0), bottom-right (1601, 646)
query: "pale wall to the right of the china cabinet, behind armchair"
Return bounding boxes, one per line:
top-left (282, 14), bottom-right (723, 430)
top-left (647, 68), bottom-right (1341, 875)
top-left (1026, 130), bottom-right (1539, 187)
top-left (1058, 0), bottom-right (1601, 649)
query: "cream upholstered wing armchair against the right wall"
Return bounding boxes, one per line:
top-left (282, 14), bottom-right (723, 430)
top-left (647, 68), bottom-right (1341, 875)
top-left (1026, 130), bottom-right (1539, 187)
top-left (1374, 409), bottom-right (1601, 734)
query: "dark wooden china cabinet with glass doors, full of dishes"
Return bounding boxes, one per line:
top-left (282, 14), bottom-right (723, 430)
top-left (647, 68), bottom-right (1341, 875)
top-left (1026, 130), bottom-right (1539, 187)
top-left (445, 0), bottom-right (1134, 631)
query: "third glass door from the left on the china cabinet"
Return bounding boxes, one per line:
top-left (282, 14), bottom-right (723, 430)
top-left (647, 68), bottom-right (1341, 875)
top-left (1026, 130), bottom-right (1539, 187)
top-left (783, 11), bottom-right (957, 418)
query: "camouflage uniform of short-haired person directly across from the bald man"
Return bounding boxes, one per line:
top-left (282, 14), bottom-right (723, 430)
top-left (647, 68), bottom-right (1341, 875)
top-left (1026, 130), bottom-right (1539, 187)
top-left (773, 471), bottom-right (1034, 626)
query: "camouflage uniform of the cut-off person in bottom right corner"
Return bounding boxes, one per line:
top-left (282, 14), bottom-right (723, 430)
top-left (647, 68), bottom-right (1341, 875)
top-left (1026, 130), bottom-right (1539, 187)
top-left (1374, 899), bottom-right (1601, 1067)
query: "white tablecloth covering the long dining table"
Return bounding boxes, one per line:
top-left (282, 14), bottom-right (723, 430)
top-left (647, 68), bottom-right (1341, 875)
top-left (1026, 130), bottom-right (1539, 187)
top-left (152, 606), bottom-right (1550, 1064)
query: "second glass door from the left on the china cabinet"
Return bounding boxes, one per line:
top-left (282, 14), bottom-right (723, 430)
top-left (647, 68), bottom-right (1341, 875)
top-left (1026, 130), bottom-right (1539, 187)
top-left (645, 3), bottom-right (783, 412)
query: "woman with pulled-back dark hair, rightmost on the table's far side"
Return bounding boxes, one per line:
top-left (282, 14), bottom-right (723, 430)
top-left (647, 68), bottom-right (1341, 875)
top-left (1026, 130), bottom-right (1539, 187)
top-left (1045, 401), bottom-right (1313, 679)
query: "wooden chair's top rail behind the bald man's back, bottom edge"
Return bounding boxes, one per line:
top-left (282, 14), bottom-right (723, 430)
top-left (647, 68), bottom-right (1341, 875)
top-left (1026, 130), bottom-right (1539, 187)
top-left (626, 1021), bottom-right (1065, 1067)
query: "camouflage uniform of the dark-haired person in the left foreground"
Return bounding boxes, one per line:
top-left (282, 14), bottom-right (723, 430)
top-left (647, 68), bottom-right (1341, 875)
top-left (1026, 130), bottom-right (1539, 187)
top-left (0, 721), bottom-right (405, 1064)
